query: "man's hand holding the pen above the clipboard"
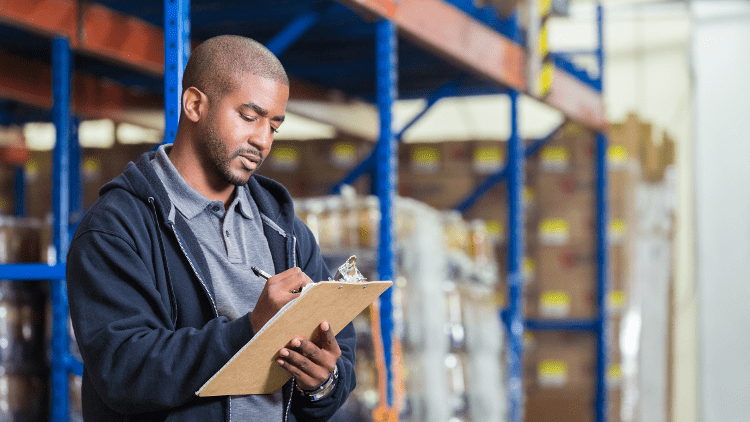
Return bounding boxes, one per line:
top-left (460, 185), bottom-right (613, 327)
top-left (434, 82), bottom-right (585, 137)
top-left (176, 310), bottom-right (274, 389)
top-left (250, 267), bottom-right (312, 333)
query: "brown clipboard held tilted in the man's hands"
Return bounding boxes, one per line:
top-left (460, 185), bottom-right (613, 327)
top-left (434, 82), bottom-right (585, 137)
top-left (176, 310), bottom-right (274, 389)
top-left (195, 281), bottom-right (393, 397)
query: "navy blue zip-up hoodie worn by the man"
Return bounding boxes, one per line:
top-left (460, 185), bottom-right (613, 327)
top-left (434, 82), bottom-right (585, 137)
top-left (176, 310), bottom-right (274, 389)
top-left (67, 152), bottom-right (356, 422)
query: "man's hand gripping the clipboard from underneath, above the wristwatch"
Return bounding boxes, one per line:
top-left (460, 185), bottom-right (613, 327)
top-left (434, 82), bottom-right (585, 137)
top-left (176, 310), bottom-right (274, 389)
top-left (276, 321), bottom-right (341, 390)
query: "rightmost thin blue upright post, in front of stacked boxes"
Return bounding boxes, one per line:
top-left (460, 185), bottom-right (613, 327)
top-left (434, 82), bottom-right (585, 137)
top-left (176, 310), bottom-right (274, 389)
top-left (596, 4), bottom-right (609, 422)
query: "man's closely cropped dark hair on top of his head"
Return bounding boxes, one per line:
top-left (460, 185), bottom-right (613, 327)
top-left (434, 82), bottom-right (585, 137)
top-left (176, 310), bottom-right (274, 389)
top-left (182, 35), bottom-right (289, 99)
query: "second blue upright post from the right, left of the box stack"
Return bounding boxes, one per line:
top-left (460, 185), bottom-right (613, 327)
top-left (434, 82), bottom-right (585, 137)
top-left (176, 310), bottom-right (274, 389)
top-left (507, 91), bottom-right (525, 422)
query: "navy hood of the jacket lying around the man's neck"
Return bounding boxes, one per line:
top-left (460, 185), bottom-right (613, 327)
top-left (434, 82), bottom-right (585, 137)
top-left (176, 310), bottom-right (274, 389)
top-left (99, 151), bottom-right (294, 231)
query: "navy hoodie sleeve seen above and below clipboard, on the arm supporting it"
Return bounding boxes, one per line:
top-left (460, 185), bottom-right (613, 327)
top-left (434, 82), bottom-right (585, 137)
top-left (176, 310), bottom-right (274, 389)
top-left (291, 218), bottom-right (357, 421)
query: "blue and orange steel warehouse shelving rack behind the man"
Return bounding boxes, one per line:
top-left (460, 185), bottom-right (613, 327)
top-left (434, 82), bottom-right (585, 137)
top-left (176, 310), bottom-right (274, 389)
top-left (0, 0), bottom-right (607, 422)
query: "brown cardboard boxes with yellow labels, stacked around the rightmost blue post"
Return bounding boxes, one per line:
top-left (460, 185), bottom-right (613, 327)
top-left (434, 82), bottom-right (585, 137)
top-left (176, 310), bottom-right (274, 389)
top-left (524, 119), bottom-right (637, 422)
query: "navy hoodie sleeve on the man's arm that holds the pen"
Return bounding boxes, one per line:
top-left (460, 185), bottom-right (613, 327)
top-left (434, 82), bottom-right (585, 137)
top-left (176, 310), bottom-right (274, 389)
top-left (67, 226), bottom-right (253, 414)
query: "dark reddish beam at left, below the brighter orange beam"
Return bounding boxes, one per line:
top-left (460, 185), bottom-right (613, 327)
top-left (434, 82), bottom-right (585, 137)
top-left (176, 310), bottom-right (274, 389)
top-left (0, 51), bottom-right (163, 118)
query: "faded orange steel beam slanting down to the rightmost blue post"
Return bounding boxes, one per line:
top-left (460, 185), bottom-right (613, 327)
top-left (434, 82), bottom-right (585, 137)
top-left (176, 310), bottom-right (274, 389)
top-left (338, 0), bottom-right (606, 130)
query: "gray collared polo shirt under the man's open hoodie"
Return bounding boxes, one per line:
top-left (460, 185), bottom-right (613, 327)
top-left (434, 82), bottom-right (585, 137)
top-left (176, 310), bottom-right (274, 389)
top-left (151, 144), bottom-right (284, 421)
